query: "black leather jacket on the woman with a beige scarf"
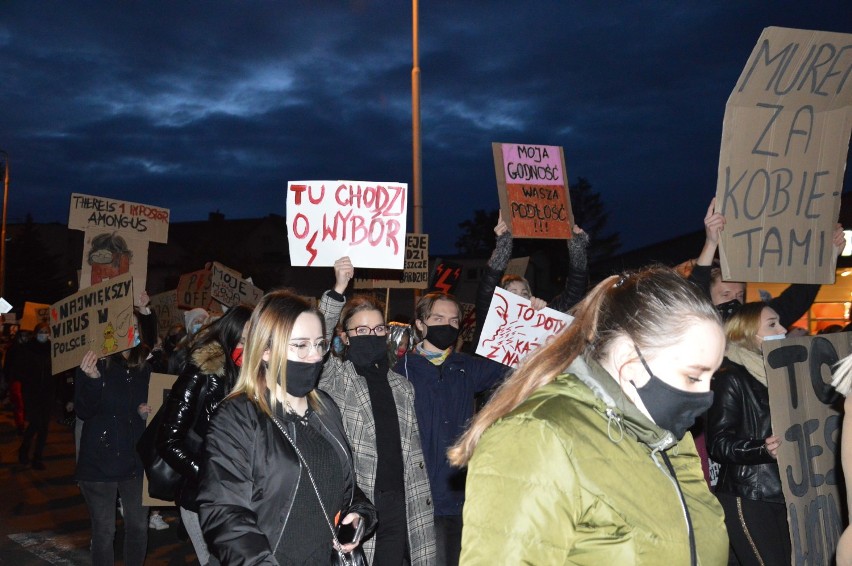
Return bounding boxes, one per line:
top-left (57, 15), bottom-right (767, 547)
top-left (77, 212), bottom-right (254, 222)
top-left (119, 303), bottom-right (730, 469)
top-left (707, 358), bottom-right (784, 504)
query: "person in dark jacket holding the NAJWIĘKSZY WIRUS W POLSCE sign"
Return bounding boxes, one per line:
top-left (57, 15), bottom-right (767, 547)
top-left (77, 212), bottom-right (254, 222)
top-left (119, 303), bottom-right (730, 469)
top-left (74, 311), bottom-right (151, 566)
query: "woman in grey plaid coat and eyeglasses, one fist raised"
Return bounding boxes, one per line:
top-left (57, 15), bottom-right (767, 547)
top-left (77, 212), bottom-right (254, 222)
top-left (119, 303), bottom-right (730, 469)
top-left (319, 257), bottom-right (435, 566)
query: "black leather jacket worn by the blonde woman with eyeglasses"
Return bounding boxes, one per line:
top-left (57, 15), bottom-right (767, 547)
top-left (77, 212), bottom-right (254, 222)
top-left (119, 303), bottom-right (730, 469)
top-left (197, 390), bottom-right (376, 565)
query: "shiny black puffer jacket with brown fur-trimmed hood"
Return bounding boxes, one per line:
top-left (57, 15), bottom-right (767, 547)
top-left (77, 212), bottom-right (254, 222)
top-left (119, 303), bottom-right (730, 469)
top-left (157, 342), bottom-right (236, 512)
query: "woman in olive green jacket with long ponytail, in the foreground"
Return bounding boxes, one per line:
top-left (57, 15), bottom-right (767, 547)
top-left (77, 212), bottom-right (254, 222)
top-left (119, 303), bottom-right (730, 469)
top-left (450, 267), bottom-right (728, 566)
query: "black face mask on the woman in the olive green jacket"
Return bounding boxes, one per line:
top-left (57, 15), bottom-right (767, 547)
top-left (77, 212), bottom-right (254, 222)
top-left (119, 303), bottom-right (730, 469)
top-left (636, 349), bottom-right (713, 440)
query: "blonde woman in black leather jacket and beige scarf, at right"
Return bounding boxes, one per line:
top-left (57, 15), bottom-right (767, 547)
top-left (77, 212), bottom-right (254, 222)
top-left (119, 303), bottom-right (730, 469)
top-left (707, 303), bottom-right (791, 566)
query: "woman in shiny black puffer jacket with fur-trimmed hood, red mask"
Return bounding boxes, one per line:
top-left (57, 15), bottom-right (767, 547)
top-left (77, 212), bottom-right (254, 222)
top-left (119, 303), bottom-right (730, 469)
top-left (157, 305), bottom-right (251, 566)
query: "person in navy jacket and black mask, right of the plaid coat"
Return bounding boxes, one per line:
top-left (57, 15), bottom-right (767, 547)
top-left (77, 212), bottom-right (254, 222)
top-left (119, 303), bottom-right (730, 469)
top-left (394, 293), bottom-right (509, 565)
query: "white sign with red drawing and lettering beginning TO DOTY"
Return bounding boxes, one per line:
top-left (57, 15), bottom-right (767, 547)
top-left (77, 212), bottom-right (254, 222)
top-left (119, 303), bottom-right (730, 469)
top-left (476, 287), bottom-right (574, 368)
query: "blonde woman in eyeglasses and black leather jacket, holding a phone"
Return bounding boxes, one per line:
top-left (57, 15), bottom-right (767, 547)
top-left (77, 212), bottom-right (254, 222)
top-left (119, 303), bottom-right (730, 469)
top-left (196, 291), bottom-right (376, 565)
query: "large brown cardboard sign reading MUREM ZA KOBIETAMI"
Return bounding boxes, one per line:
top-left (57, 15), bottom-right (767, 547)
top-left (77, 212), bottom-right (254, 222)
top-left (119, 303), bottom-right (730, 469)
top-left (716, 27), bottom-right (852, 283)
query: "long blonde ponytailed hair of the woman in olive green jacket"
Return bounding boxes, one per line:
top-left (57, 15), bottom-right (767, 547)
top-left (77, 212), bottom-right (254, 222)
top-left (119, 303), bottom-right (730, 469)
top-left (447, 266), bottom-right (721, 466)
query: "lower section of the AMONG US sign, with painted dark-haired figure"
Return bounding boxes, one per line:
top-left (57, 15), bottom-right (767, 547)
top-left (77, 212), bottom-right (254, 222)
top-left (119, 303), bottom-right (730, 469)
top-left (80, 230), bottom-right (148, 290)
